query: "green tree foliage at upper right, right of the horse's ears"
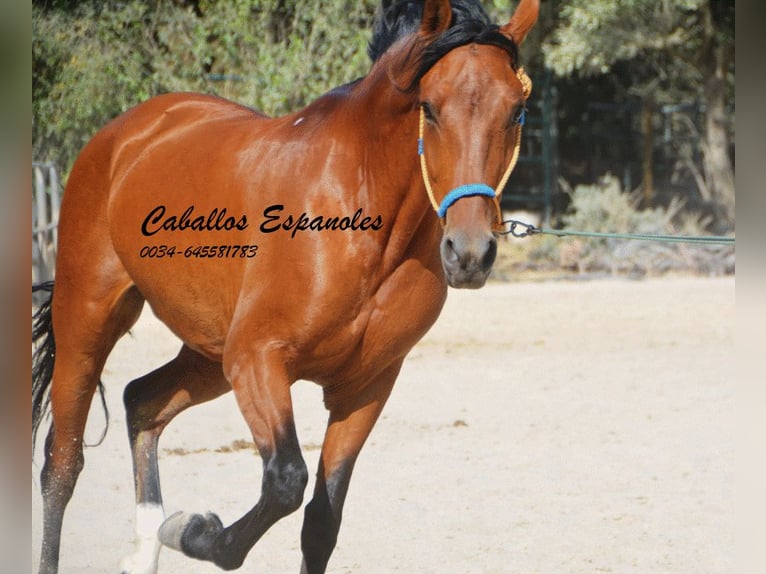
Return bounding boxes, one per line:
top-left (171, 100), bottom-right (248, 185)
top-left (542, 0), bottom-right (734, 109)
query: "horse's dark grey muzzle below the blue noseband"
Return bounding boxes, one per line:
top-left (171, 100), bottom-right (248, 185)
top-left (441, 233), bottom-right (497, 289)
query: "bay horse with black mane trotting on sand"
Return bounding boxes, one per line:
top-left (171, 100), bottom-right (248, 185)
top-left (33, 0), bottom-right (539, 574)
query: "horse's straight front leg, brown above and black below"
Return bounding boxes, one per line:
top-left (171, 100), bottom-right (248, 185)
top-left (301, 360), bottom-right (402, 574)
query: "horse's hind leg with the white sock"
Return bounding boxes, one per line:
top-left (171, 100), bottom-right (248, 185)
top-left (122, 346), bottom-right (231, 574)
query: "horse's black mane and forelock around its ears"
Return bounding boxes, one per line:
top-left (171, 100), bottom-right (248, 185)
top-left (367, 0), bottom-right (518, 90)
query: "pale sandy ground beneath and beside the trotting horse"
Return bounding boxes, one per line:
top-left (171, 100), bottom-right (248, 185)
top-left (32, 278), bottom-right (735, 574)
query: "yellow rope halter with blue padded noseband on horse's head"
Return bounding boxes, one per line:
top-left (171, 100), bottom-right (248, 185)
top-left (418, 67), bottom-right (532, 234)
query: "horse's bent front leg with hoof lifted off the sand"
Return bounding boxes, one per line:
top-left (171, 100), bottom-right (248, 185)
top-left (159, 349), bottom-right (308, 570)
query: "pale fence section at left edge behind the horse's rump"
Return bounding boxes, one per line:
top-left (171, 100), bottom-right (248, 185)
top-left (32, 162), bottom-right (61, 283)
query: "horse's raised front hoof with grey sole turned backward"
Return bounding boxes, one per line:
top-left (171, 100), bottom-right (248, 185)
top-left (157, 511), bottom-right (223, 560)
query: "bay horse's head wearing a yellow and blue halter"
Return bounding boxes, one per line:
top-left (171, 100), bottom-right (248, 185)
top-left (412, 0), bottom-right (539, 288)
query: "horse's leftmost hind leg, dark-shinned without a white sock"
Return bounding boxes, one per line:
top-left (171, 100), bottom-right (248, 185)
top-left (40, 279), bottom-right (143, 573)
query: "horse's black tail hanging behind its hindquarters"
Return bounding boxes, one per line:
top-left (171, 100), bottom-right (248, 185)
top-left (32, 281), bottom-right (109, 452)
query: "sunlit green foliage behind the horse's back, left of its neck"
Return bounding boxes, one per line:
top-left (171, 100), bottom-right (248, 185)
top-left (32, 0), bottom-right (377, 176)
